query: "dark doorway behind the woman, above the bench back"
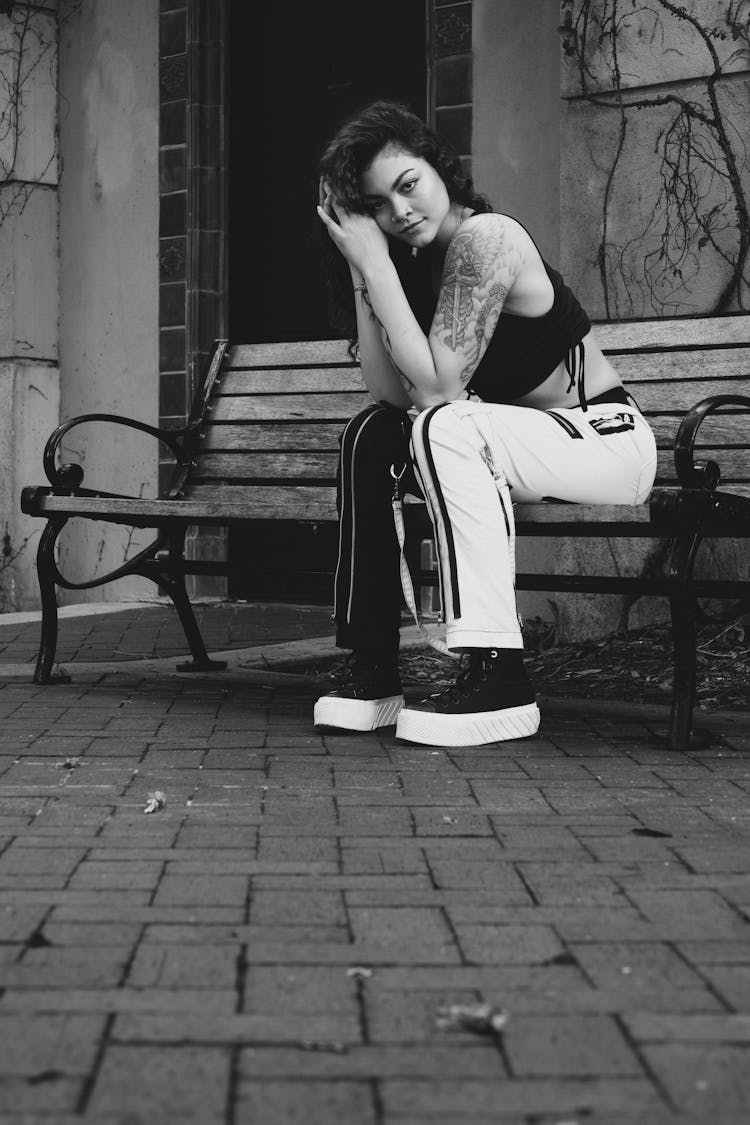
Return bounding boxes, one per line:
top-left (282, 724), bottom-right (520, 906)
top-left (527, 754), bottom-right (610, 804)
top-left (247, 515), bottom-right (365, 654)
top-left (227, 0), bottom-right (427, 343)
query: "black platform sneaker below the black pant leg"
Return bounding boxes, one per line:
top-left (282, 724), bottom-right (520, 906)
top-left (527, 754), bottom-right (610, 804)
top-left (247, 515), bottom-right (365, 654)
top-left (313, 653), bottom-right (404, 730)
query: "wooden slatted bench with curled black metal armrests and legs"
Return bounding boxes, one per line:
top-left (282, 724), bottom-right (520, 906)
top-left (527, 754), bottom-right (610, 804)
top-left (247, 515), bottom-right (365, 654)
top-left (21, 315), bottom-right (750, 747)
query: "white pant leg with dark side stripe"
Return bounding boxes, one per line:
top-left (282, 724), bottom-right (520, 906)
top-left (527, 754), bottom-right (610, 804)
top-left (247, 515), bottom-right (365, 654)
top-left (412, 399), bottom-right (656, 649)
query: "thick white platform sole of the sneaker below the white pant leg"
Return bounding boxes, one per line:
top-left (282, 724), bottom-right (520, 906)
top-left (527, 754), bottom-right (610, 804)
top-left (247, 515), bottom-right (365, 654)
top-left (396, 703), bottom-right (540, 746)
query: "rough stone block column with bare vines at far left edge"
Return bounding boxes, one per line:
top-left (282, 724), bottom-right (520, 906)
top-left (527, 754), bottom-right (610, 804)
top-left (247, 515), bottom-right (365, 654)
top-left (0, 2), bottom-right (60, 612)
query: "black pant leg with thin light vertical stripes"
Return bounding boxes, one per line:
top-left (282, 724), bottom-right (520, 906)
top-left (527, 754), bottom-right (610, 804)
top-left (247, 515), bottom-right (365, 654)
top-left (334, 405), bottom-right (412, 655)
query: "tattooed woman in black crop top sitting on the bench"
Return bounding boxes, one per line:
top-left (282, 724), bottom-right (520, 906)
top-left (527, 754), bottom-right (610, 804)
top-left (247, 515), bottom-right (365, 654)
top-left (315, 101), bottom-right (656, 746)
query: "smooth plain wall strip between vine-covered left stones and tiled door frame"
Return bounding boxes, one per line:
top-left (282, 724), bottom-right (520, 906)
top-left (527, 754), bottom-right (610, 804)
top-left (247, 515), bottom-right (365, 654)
top-left (60, 0), bottom-right (159, 602)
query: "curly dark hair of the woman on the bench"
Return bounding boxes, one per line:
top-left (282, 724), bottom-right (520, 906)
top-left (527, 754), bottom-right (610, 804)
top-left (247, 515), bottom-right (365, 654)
top-left (318, 101), bottom-right (491, 342)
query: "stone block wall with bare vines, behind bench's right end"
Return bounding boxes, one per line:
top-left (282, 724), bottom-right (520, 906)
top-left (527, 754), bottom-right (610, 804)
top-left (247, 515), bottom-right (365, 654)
top-left (546, 0), bottom-right (750, 639)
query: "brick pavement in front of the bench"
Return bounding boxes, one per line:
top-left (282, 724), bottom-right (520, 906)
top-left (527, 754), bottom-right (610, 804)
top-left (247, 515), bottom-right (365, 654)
top-left (0, 610), bottom-right (750, 1125)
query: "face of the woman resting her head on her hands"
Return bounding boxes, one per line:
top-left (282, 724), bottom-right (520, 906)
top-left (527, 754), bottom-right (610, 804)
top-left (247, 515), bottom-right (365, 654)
top-left (361, 146), bottom-right (460, 248)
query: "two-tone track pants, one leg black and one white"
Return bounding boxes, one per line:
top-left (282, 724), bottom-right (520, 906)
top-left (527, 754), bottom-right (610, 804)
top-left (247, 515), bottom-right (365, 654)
top-left (334, 399), bottom-right (657, 650)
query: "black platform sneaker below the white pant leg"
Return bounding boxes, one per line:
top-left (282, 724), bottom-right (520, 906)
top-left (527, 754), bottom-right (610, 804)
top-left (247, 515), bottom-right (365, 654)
top-left (396, 648), bottom-right (539, 746)
